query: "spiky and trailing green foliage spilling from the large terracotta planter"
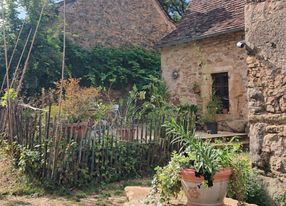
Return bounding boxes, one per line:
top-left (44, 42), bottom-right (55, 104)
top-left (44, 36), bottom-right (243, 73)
top-left (151, 119), bottom-right (247, 202)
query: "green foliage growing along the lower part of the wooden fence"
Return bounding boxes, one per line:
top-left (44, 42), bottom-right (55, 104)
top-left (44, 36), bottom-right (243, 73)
top-left (0, 136), bottom-right (152, 188)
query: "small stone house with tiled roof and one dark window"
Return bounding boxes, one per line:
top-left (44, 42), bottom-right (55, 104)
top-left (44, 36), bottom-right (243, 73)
top-left (158, 0), bottom-right (248, 132)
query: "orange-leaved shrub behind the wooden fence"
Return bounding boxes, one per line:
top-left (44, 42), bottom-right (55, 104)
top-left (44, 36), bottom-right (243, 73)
top-left (51, 77), bottom-right (101, 138)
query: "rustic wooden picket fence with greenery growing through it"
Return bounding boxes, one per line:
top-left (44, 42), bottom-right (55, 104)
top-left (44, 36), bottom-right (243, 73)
top-left (0, 106), bottom-right (180, 184)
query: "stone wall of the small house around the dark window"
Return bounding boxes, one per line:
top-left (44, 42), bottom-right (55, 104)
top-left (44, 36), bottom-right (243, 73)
top-left (161, 32), bottom-right (248, 132)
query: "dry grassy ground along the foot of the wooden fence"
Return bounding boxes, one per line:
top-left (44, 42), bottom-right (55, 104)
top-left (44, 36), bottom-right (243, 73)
top-left (0, 149), bottom-right (150, 206)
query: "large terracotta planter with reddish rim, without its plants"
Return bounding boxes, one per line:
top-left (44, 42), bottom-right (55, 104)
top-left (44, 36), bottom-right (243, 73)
top-left (181, 169), bottom-right (232, 206)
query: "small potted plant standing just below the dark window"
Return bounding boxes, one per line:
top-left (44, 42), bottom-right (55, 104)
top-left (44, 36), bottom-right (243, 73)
top-left (203, 92), bottom-right (221, 134)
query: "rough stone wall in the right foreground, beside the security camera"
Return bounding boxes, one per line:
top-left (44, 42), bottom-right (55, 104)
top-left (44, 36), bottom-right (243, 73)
top-left (245, 0), bottom-right (286, 205)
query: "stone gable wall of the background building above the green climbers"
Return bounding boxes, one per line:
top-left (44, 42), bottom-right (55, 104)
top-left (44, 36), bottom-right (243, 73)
top-left (59, 0), bottom-right (175, 48)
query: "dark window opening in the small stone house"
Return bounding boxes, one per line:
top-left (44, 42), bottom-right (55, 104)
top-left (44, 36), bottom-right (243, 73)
top-left (212, 72), bottom-right (229, 114)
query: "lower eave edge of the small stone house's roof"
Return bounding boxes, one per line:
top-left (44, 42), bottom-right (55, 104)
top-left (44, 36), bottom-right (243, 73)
top-left (155, 27), bottom-right (245, 49)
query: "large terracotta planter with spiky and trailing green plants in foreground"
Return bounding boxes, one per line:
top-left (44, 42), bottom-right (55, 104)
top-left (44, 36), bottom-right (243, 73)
top-left (149, 120), bottom-right (244, 206)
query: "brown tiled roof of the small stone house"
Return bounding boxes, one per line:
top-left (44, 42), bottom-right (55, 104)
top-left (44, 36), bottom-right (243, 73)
top-left (158, 0), bottom-right (245, 47)
